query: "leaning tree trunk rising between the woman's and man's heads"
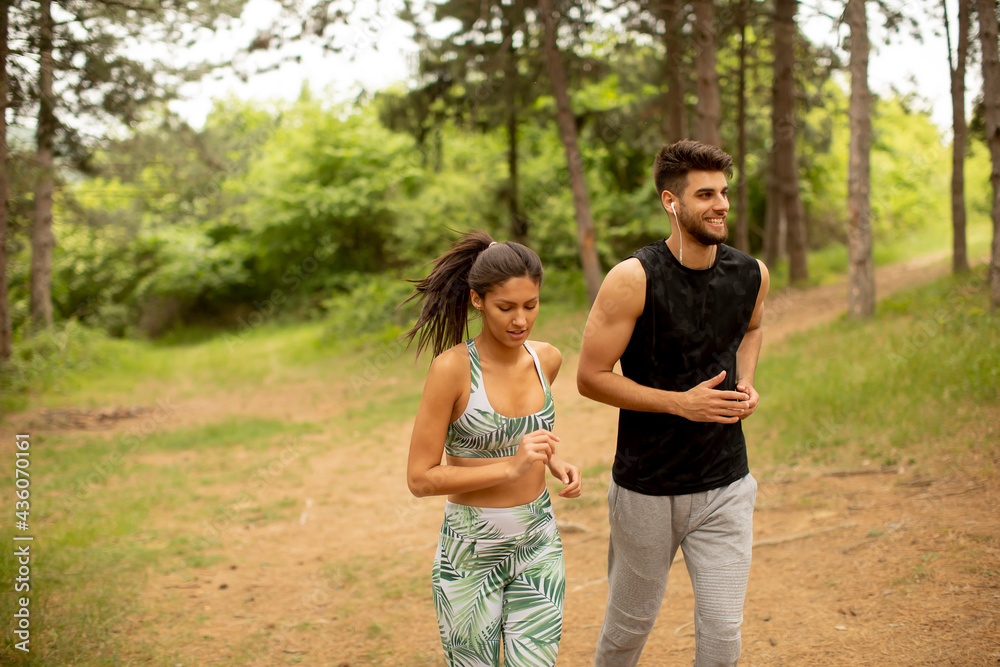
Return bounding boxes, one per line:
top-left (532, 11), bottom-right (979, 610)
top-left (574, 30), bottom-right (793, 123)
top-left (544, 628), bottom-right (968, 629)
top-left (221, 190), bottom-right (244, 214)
top-left (539, 0), bottom-right (602, 305)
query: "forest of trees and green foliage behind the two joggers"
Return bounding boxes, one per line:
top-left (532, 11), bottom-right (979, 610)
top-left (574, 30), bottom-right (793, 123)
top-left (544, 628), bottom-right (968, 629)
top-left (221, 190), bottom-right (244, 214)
top-left (0, 0), bottom-right (1000, 391)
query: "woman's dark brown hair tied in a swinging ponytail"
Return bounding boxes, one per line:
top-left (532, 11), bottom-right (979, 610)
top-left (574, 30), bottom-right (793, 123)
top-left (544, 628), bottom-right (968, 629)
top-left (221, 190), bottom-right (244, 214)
top-left (401, 230), bottom-right (542, 356)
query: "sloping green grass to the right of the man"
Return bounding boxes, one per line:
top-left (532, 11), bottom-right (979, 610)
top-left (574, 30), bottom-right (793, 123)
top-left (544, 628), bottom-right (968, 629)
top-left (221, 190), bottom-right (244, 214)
top-left (746, 268), bottom-right (1000, 465)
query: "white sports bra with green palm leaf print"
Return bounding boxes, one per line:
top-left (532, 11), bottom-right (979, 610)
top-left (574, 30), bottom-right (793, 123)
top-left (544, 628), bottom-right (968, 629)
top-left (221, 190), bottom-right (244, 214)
top-left (444, 338), bottom-right (556, 459)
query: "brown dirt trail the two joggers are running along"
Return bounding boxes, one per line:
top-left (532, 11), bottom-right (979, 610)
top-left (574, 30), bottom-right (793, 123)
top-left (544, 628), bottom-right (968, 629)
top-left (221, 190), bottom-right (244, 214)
top-left (9, 250), bottom-right (1000, 667)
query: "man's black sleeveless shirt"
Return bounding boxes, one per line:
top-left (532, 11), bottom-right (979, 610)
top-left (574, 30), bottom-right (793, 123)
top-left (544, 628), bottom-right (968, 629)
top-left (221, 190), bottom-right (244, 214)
top-left (612, 240), bottom-right (761, 496)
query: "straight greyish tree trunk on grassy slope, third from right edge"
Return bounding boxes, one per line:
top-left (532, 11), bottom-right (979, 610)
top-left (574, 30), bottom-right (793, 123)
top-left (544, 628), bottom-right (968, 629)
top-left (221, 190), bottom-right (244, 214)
top-left (846, 0), bottom-right (875, 319)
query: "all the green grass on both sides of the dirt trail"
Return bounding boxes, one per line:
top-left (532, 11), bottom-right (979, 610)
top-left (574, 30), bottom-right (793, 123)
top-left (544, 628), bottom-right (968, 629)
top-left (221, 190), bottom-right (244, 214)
top-left (0, 240), bottom-right (1000, 665)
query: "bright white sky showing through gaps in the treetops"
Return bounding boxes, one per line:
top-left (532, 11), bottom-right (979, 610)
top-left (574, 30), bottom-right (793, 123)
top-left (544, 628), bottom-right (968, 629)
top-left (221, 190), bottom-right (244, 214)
top-left (172, 0), bottom-right (968, 129)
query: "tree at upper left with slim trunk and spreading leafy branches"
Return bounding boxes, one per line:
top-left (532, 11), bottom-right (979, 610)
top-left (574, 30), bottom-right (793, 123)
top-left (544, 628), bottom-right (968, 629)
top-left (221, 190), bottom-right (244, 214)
top-left (24, 0), bottom-right (246, 327)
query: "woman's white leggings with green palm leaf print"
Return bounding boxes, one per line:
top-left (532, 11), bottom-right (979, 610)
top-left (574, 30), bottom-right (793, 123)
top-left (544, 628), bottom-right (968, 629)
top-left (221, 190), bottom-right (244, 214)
top-left (432, 491), bottom-right (566, 667)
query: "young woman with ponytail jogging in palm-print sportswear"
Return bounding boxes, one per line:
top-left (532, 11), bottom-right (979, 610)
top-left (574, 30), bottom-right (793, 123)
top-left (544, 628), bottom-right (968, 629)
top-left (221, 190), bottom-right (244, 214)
top-left (406, 232), bottom-right (581, 667)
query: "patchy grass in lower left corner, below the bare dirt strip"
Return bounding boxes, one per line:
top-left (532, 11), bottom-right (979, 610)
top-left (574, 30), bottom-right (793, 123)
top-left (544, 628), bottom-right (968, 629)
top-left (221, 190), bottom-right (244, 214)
top-left (0, 419), bottom-right (324, 665)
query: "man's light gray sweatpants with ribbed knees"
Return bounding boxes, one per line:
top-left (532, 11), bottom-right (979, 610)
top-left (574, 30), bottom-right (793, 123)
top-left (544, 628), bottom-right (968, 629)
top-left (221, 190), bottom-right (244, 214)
top-left (594, 475), bottom-right (757, 667)
